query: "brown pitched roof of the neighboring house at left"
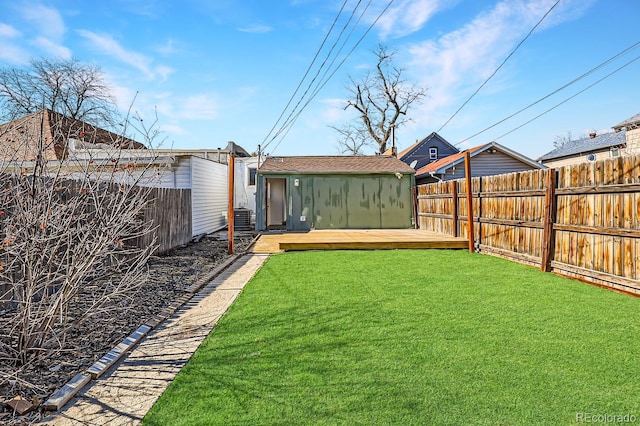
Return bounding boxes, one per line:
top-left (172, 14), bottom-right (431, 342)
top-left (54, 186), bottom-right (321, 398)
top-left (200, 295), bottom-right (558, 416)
top-left (0, 109), bottom-right (146, 161)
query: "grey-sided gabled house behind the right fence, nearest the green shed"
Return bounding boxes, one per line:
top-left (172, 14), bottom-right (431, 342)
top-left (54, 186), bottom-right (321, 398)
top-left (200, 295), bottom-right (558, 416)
top-left (416, 142), bottom-right (546, 185)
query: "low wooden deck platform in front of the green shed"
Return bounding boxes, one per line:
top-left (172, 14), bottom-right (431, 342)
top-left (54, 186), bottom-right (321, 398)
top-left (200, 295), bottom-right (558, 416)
top-left (251, 229), bottom-right (469, 253)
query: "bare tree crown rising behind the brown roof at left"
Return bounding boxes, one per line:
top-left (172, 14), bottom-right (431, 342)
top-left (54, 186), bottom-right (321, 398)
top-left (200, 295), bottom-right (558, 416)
top-left (0, 58), bottom-right (119, 128)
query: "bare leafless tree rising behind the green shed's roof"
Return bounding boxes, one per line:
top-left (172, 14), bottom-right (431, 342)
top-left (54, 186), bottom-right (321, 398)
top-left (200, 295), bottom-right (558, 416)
top-left (334, 44), bottom-right (427, 154)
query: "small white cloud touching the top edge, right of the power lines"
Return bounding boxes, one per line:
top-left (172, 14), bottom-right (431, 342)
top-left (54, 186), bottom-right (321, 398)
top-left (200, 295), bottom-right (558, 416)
top-left (375, 0), bottom-right (444, 38)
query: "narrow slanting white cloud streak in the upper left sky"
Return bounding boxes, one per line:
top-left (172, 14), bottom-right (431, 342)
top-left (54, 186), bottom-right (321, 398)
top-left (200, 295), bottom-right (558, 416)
top-left (78, 30), bottom-right (173, 80)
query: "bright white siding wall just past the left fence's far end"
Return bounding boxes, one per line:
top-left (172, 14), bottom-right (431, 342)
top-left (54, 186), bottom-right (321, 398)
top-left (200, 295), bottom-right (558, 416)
top-left (191, 157), bottom-right (228, 236)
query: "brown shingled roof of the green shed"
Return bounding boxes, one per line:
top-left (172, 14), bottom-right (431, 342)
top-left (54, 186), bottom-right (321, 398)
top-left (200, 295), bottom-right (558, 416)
top-left (259, 155), bottom-right (415, 174)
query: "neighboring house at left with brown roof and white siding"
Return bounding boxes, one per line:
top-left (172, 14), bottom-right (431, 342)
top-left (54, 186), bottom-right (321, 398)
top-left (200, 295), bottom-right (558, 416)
top-left (0, 110), bottom-right (240, 236)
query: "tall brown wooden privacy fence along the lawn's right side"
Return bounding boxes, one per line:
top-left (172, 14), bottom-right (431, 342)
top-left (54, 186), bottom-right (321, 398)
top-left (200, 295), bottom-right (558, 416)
top-left (418, 157), bottom-right (640, 294)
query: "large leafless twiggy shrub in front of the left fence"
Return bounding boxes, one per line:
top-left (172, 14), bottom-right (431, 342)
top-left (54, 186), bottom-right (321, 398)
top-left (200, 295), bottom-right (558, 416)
top-left (0, 104), bottom-right (162, 365)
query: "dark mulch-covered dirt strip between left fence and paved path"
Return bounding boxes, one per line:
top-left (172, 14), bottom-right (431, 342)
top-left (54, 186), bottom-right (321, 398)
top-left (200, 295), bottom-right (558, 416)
top-left (0, 232), bottom-right (253, 425)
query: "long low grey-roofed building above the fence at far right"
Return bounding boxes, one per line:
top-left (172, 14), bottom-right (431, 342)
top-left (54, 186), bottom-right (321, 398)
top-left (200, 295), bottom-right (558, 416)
top-left (538, 131), bottom-right (627, 167)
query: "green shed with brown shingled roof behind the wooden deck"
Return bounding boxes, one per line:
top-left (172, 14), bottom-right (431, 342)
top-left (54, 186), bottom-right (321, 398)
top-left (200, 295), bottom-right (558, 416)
top-left (256, 155), bottom-right (415, 231)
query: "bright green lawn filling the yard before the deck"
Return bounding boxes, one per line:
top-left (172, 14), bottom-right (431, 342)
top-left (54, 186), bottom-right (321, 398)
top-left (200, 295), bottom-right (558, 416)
top-left (144, 250), bottom-right (640, 425)
